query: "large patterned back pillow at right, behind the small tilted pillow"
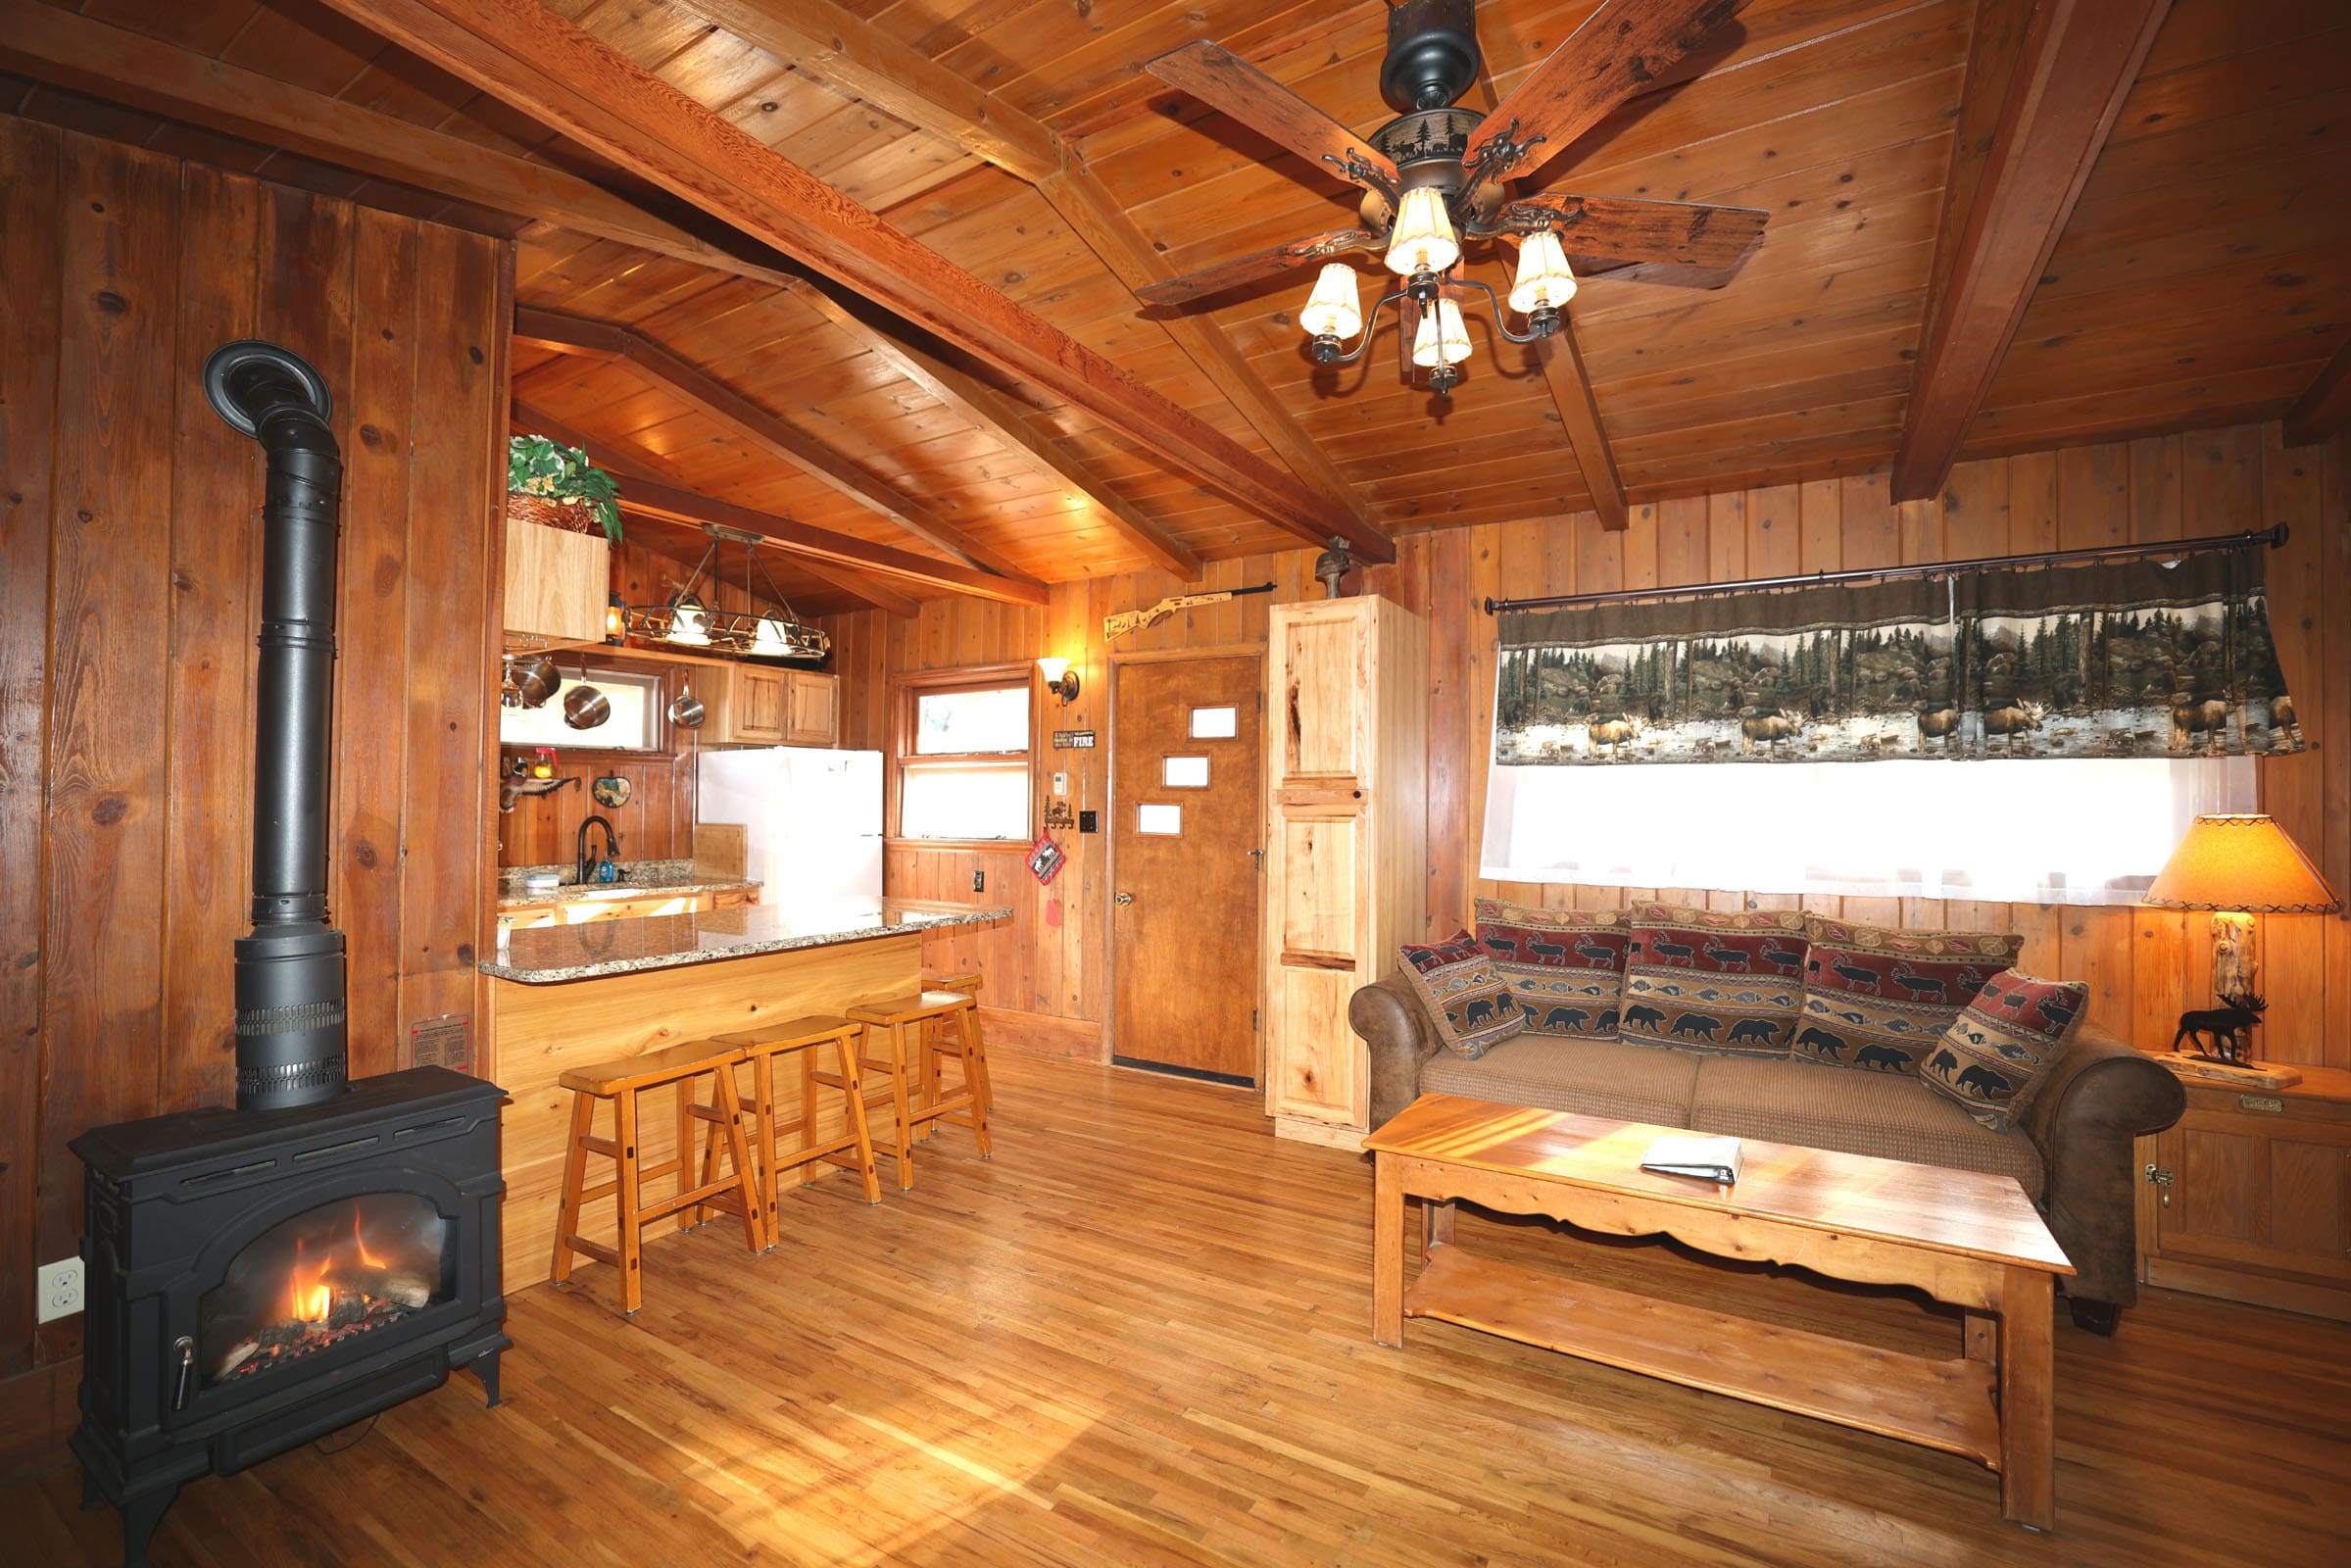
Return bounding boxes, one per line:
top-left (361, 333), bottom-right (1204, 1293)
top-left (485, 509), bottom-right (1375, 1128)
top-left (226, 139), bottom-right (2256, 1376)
top-left (1791, 914), bottom-right (2025, 1077)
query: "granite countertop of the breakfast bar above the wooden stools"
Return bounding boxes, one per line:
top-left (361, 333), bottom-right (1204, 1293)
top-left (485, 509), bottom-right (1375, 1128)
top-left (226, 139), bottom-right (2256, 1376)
top-left (479, 898), bottom-right (1011, 985)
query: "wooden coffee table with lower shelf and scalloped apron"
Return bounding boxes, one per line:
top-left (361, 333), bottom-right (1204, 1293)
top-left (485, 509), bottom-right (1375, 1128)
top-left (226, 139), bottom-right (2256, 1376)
top-left (1363, 1096), bottom-right (2074, 1531)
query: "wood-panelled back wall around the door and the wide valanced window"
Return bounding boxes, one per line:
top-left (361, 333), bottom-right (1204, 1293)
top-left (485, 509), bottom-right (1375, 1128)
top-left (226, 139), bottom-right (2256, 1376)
top-left (830, 425), bottom-right (2351, 1065)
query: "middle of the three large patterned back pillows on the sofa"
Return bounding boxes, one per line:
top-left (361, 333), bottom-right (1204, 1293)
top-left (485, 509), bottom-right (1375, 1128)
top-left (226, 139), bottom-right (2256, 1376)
top-left (1618, 903), bottom-right (1803, 1055)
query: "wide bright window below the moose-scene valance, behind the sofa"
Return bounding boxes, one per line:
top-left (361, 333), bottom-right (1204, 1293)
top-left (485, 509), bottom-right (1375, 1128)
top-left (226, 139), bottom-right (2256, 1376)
top-left (1481, 757), bottom-right (2257, 906)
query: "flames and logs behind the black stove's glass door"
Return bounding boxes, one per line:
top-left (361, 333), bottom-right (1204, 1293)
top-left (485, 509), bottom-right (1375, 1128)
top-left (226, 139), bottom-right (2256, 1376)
top-left (200, 1192), bottom-right (449, 1385)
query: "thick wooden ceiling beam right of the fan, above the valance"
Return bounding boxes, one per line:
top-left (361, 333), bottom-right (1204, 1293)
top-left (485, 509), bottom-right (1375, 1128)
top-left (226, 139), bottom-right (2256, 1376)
top-left (1892, 0), bottom-right (2170, 501)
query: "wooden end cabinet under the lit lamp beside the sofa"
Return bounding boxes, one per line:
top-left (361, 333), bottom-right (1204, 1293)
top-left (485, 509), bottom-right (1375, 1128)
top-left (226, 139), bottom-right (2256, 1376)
top-left (2139, 1067), bottom-right (2351, 1319)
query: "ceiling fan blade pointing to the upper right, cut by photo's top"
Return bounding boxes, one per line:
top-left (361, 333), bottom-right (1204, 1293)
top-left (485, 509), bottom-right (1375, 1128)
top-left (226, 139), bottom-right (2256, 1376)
top-left (1462, 0), bottom-right (1746, 170)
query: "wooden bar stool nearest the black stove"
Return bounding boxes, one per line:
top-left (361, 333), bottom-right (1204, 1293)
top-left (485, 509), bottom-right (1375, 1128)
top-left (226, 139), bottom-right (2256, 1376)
top-left (548, 1039), bottom-right (761, 1312)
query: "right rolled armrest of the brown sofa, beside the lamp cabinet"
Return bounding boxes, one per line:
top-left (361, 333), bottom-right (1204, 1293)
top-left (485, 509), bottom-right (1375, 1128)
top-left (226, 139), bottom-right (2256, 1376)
top-left (2025, 1022), bottom-right (2188, 1307)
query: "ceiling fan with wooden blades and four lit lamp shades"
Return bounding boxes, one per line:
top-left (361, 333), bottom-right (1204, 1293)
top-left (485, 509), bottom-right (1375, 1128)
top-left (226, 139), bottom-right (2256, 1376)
top-left (1136, 0), bottom-right (1770, 397)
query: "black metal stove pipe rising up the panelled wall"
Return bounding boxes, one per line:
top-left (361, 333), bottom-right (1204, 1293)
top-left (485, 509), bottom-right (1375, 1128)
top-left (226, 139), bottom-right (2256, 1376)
top-left (205, 341), bottom-right (350, 1109)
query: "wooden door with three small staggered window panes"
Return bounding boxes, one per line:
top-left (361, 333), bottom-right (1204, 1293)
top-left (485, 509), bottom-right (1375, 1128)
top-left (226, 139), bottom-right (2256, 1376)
top-left (1109, 654), bottom-right (1265, 1084)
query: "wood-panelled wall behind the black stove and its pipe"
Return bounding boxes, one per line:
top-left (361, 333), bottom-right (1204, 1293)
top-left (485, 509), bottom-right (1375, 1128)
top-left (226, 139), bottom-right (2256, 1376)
top-left (0, 118), bottom-right (513, 1452)
